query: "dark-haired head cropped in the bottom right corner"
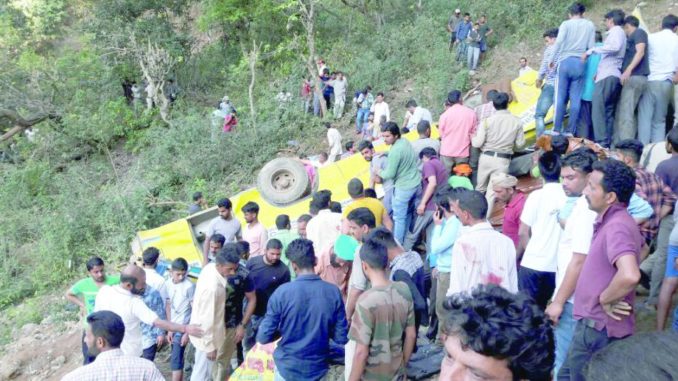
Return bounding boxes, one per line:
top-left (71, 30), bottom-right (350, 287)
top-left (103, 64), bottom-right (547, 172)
top-left (584, 331), bottom-right (678, 381)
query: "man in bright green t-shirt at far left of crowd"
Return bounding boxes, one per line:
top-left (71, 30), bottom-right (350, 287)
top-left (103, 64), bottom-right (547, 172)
top-left (66, 257), bottom-right (120, 365)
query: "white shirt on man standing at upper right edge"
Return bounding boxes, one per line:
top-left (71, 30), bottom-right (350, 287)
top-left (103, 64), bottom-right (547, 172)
top-left (647, 29), bottom-right (678, 81)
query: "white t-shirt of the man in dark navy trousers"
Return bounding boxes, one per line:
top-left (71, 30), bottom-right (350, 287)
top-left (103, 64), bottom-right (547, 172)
top-left (520, 183), bottom-right (567, 272)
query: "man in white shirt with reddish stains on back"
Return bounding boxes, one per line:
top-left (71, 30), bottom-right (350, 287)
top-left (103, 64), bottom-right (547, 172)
top-left (447, 190), bottom-right (518, 296)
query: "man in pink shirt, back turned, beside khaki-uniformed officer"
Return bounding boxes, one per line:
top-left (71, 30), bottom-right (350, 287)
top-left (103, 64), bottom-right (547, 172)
top-left (438, 90), bottom-right (478, 173)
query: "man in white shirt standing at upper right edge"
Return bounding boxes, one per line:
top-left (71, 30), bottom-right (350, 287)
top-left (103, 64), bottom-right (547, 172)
top-left (638, 15), bottom-right (678, 144)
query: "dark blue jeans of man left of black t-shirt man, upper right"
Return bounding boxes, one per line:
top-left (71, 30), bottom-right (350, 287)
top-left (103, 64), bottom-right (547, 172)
top-left (591, 75), bottom-right (621, 147)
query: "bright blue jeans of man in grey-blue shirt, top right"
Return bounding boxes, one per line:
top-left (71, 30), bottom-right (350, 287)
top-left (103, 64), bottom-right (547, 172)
top-left (553, 57), bottom-right (586, 134)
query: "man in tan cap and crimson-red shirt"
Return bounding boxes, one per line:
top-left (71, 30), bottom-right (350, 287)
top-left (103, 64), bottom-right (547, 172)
top-left (489, 173), bottom-right (526, 248)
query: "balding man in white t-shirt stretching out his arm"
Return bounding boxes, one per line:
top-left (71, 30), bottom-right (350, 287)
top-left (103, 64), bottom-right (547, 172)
top-left (94, 265), bottom-right (203, 357)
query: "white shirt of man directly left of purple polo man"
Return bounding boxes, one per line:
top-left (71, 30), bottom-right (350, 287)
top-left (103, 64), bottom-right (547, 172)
top-left (553, 196), bottom-right (596, 304)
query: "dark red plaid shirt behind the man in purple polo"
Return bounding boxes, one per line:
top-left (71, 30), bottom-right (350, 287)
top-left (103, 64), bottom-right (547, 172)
top-left (635, 168), bottom-right (676, 240)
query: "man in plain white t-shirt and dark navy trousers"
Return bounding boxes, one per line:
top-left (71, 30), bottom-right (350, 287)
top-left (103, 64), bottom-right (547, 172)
top-left (518, 151), bottom-right (566, 309)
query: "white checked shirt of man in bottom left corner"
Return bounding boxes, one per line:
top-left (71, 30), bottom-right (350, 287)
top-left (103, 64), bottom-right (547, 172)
top-left (61, 348), bottom-right (165, 381)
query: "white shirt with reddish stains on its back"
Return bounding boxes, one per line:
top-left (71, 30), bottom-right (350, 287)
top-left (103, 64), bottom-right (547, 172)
top-left (447, 222), bottom-right (518, 296)
